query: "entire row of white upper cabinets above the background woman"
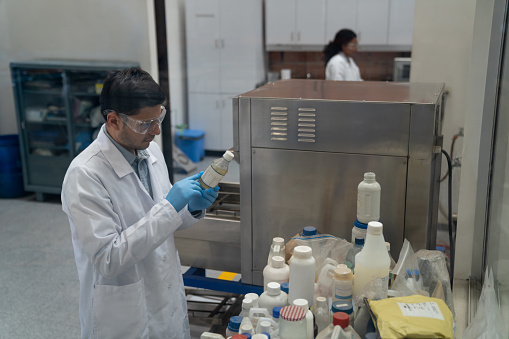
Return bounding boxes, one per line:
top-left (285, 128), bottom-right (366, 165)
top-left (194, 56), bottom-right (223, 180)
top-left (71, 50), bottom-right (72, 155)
top-left (265, 0), bottom-right (415, 51)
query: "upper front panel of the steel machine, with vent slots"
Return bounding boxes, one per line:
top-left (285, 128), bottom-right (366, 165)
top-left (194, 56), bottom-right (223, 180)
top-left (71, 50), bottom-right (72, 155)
top-left (251, 99), bottom-right (410, 156)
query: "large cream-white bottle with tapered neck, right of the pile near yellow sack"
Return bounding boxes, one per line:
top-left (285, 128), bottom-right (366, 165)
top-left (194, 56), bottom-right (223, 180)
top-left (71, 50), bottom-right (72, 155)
top-left (353, 221), bottom-right (391, 298)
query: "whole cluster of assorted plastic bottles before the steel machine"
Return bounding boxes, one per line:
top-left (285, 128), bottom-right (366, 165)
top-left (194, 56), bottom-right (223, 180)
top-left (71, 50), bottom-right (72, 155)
top-left (201, 173), bottom-right (395, 339)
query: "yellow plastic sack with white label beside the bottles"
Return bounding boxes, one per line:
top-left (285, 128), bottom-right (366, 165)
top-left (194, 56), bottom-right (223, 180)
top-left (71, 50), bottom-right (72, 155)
top-left (365, 295), bottom-right (454, 339)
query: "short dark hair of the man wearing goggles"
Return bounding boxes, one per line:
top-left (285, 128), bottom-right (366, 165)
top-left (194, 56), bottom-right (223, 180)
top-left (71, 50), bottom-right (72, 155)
top-left (100, 67), bottom-right (166, 120)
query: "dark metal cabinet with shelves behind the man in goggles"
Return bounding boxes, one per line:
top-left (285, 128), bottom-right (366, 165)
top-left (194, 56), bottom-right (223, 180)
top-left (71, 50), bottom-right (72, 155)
top-left (10, 60), bottom-right (137, 200)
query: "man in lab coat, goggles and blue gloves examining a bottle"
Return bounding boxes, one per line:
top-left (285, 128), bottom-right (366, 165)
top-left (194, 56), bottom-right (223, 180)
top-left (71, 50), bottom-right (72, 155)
top-left (62, 68), bottom-right (219, 339)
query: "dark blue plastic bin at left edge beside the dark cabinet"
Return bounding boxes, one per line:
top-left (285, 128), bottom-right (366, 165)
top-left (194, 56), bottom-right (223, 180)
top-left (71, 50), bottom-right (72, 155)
top-left (0, 134), bottom-right (25, 199)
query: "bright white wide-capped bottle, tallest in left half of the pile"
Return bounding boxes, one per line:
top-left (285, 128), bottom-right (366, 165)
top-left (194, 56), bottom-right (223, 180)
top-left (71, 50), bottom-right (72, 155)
top-left (288, 246), bottom-right (316, 305)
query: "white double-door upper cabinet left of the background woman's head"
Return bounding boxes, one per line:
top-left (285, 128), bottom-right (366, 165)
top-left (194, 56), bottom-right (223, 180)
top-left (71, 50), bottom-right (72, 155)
top-left (265, 0), bottom-right (325, 49)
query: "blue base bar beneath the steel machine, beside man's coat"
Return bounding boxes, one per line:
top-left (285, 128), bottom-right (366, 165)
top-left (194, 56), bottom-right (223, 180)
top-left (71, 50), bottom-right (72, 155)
top-left (183, 267), bottom-right (263, 295)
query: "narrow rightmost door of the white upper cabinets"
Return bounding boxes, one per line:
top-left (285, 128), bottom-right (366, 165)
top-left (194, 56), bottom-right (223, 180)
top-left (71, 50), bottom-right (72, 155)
top-left (388, 0), bottom-right (415, 45)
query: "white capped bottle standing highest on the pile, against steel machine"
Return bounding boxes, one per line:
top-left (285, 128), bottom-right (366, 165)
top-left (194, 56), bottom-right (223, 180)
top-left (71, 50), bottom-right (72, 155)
top-left (357, 172), bottom-right (381, 224)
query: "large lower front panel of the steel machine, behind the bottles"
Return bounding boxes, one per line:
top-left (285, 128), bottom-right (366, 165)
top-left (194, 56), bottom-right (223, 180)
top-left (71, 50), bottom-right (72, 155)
top-left (249, 148), bottom-right (407, 284)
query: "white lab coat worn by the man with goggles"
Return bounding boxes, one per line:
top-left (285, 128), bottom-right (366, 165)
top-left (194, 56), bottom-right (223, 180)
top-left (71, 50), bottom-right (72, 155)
top-left (62, 128), bottom-right (200, 339)
